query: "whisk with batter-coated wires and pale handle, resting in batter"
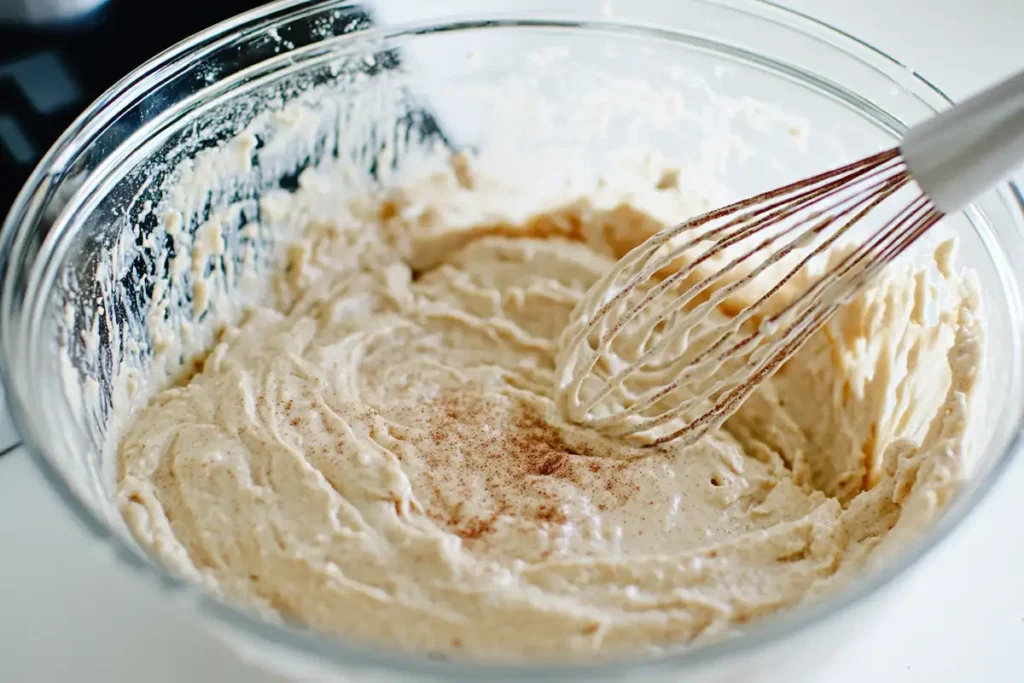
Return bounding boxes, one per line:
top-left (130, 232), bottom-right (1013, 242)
top-left (556, 68), bottom-right (1024, 444)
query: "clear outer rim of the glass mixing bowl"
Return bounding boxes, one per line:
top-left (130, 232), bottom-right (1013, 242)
top-left (0, 0), bottom-right (1024, 681)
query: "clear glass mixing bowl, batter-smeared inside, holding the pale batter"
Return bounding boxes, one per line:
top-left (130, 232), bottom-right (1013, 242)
top-left (0, 0), bottom-right (1024, 681)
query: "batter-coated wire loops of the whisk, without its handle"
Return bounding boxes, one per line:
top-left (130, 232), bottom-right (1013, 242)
top-left (556, 148), bottom-right (942, 444)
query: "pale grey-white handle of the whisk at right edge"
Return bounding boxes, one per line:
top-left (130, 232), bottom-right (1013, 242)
top-left (900, 72), bottom-right (1024, 214)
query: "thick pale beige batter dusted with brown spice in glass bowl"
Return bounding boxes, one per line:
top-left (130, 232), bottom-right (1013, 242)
top-left (119, 156), bottom-right (980, 659)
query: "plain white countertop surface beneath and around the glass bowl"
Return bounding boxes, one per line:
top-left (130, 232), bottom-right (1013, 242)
top-left (0, 0), bottom-right (1024, 683)
